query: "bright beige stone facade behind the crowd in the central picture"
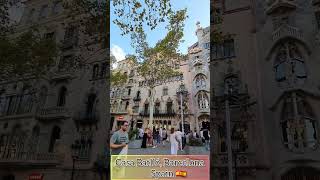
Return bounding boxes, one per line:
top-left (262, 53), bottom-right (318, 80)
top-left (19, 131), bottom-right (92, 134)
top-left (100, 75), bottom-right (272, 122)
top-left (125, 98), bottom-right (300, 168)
top-left (110, 24), bottom-right (210, 132)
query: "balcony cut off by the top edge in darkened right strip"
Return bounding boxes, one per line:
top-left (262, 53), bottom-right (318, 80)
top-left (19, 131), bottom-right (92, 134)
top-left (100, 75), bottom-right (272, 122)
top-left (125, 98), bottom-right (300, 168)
top-left (266, 0), bottom-right (297, 15)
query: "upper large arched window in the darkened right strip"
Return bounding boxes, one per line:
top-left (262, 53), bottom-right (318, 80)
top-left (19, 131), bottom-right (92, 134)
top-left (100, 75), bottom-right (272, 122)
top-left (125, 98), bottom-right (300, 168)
top-left (274, 41), bottom-right (307, 82)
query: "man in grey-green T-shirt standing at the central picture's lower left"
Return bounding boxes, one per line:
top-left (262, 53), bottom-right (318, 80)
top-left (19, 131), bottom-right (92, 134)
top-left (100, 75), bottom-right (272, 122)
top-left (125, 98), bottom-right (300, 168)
top-left (110, 121), bottom-right (129, 155)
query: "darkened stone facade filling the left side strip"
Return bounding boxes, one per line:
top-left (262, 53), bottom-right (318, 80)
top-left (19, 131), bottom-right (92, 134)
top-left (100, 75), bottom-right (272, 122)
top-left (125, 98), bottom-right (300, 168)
top-left (0, 0), bottom-right (109, 180)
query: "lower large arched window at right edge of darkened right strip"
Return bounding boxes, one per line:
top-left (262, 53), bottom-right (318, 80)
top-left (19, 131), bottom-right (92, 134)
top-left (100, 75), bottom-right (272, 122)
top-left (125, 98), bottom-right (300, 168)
top-left (281, 93), bottom-right (318, 151)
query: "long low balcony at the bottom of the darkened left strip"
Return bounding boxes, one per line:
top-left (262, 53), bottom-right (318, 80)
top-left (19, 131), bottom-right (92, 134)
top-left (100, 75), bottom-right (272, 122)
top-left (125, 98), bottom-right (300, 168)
top-left (0, 152), bottom-right (63, 167)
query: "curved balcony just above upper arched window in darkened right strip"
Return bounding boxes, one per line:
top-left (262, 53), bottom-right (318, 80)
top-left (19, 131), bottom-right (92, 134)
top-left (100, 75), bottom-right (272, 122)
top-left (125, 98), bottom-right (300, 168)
top-left (272, 24), bottom-right (303, 42)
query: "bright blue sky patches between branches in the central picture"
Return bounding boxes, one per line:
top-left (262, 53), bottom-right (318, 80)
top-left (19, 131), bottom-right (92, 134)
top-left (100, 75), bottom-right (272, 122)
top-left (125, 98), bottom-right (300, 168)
top-left (110, 0), bottom-right (210, 61)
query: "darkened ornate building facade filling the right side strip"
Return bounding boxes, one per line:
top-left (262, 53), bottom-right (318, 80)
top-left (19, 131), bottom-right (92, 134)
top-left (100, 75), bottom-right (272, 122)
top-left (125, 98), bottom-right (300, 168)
top-left (210, 0), bottom-right (320, 180)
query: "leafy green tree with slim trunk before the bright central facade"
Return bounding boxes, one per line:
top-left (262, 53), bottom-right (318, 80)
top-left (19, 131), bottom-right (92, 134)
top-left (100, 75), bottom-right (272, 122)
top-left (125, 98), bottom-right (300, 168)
top-left (134, 9), bottom-right (187, 128)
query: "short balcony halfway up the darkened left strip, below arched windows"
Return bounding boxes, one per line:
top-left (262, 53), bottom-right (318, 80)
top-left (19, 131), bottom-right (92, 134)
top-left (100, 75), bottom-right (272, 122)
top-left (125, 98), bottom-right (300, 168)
top-left (37, 107), bottom-right (70, 120)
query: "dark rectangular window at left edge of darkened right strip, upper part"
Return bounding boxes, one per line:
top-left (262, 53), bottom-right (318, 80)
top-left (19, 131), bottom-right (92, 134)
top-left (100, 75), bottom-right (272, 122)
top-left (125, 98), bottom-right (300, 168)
top-left (211, 39), bottom-right (235, 59)
